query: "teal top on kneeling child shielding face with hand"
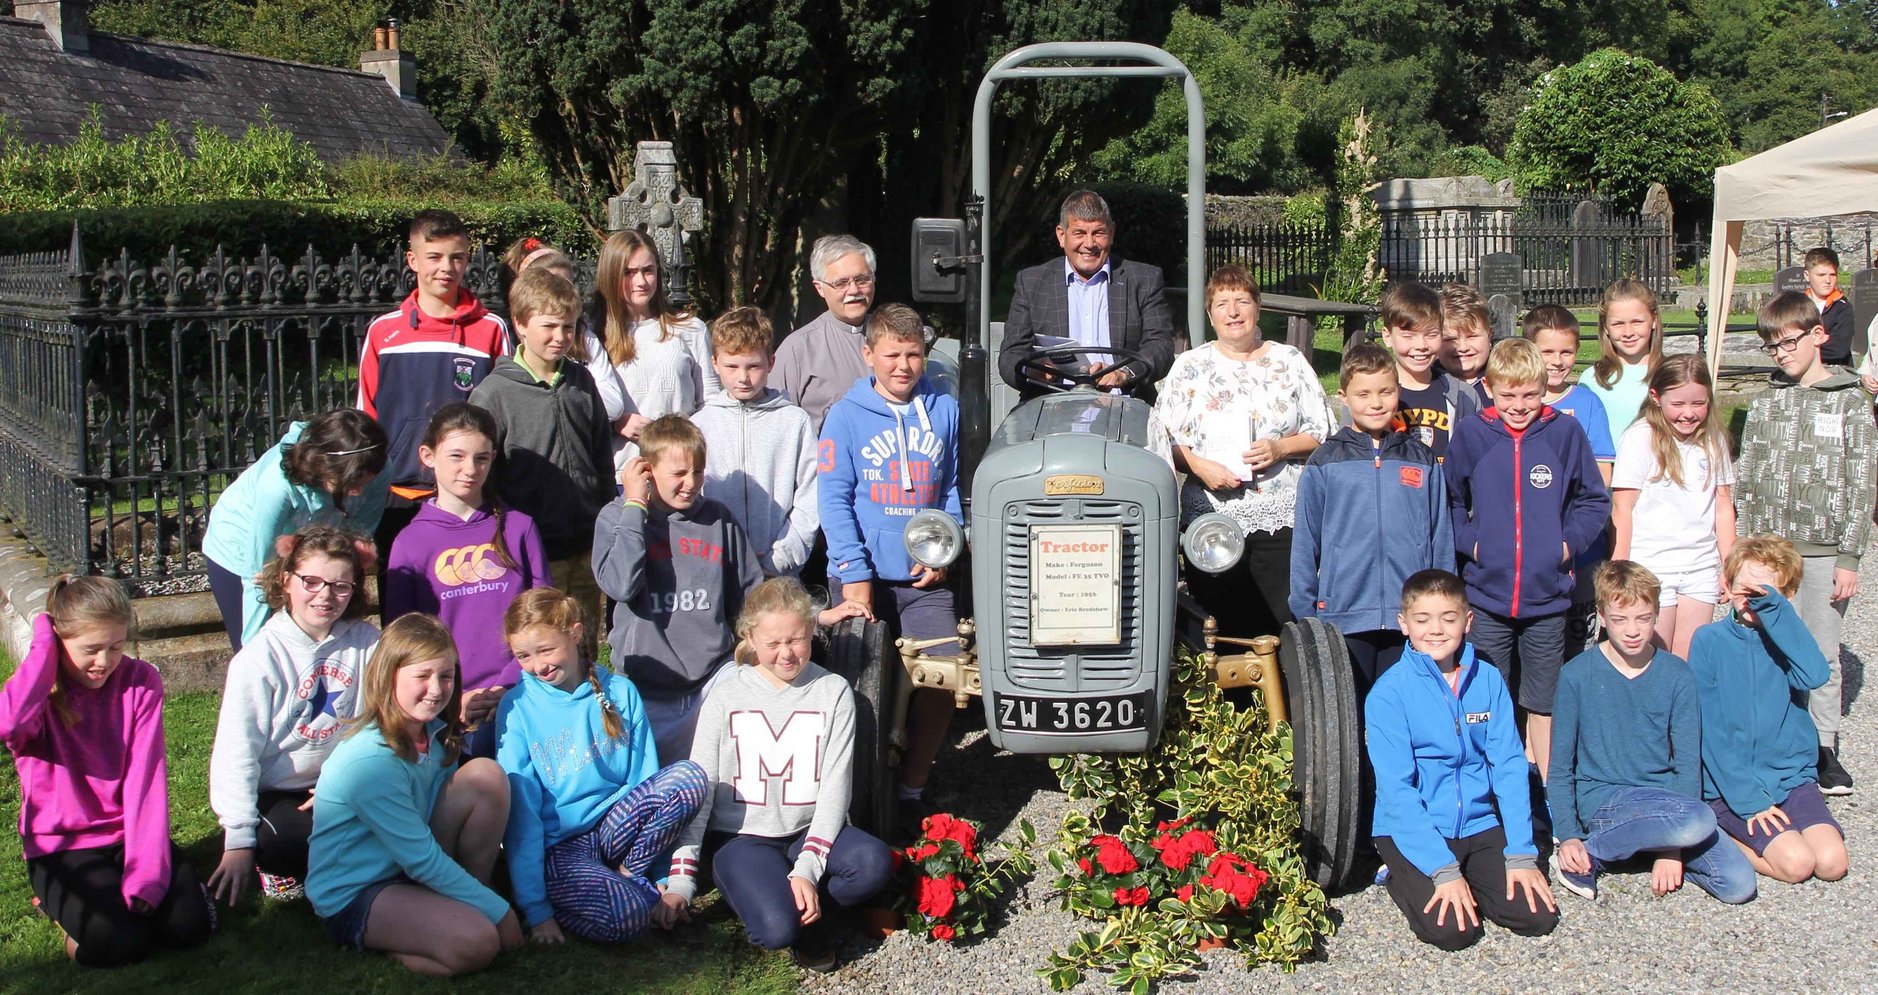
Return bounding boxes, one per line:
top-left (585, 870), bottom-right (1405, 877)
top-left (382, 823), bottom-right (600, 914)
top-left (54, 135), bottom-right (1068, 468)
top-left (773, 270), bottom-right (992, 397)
top-left (1688, 591), bottom-right (1831, 819)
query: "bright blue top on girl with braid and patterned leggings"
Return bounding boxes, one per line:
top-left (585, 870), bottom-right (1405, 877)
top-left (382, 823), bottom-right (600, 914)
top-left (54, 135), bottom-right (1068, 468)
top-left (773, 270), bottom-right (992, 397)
top-left (496, 670), bottom-right (659, 926)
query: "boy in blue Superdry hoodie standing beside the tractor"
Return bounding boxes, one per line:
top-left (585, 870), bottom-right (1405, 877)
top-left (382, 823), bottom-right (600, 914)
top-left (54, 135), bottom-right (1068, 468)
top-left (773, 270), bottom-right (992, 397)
top-left (817, 304), bottom-right (963, 809)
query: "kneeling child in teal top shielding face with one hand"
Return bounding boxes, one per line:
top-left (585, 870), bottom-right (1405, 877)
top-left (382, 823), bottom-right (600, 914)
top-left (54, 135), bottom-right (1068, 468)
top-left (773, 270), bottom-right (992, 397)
top-left (1688, 535), bottom-right (1848, 884)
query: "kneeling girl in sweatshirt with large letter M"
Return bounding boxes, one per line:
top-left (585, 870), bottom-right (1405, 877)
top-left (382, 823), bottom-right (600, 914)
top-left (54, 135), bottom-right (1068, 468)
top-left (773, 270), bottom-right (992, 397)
top-left (654, 576), bottom-right (892, 971)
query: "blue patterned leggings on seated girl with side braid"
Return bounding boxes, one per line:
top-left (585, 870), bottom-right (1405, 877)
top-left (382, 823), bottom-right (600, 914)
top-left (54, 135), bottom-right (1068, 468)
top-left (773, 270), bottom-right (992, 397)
top-left (546, 760), bottom-right (710, 942)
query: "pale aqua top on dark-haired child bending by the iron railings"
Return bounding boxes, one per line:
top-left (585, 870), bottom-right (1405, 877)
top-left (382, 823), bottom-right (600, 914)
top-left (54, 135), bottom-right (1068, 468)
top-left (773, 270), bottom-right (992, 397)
top-left (203, 422), bottom-right (391, 644)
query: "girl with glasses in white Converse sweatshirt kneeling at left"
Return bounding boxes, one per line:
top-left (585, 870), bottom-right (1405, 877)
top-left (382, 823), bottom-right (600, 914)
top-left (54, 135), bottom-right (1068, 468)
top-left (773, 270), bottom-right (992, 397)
top-left (208, 526), bottom-right (377, 905)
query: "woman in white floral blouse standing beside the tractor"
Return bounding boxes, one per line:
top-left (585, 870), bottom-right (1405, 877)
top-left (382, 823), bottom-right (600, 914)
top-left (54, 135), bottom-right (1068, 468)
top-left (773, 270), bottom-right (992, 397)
top-left (1155, 267), bottom-right (1333, 636)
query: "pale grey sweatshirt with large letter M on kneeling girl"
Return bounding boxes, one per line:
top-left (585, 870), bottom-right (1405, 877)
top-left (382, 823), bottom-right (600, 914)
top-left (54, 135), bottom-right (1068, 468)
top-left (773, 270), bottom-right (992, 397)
top-left (667, 663), bottom-right (854, 899)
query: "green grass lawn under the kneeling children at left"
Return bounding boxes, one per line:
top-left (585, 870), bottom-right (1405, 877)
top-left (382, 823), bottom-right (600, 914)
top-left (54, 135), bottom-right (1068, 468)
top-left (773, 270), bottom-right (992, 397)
top-left (0, 642), bottom-right (796, 995)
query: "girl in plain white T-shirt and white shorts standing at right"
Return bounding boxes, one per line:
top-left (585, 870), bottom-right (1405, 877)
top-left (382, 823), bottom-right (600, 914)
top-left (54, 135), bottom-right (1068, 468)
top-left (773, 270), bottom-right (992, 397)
top-left (1611, 353), bottom-right (1735, 659)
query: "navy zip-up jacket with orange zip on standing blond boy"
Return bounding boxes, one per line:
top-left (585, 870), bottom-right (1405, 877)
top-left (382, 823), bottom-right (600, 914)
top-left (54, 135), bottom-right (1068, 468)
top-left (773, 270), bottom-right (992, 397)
top-left (1446, 406), bottom-right (1611, 618)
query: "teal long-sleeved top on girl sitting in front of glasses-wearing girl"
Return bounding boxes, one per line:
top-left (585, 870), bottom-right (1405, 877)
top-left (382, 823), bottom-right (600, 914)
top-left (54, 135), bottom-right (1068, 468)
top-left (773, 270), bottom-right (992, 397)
top-left (306, 719), bottom-right (509, 924)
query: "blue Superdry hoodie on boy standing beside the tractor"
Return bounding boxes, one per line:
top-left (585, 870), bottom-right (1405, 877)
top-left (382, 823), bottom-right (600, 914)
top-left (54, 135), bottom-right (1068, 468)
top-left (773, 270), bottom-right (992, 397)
top-left (815, 375), bottom-right (965, 584)
